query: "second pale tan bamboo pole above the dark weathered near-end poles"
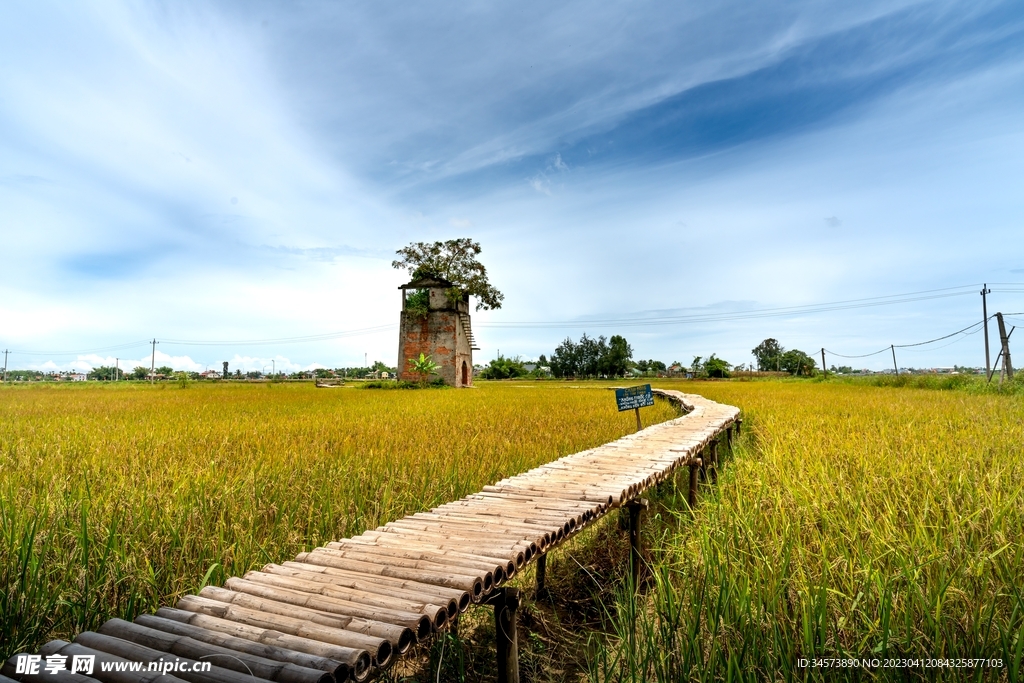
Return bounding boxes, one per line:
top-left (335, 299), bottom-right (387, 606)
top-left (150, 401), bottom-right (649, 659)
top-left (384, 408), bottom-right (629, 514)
top-left (176, 595), bottom-right (394, 668)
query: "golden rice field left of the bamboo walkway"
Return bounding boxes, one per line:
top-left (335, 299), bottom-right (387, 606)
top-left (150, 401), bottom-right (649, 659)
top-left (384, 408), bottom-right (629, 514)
top-left (0, 383), bottom-right (676, 657)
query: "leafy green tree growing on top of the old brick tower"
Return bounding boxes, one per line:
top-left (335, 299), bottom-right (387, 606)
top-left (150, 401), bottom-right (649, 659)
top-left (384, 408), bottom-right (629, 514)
top-left (391, 238), bottom-right (505, 310)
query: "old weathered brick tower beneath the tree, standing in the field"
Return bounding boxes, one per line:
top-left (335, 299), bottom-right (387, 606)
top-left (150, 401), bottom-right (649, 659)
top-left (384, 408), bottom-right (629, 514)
top-left (397, 275), bottom-right (477, 387)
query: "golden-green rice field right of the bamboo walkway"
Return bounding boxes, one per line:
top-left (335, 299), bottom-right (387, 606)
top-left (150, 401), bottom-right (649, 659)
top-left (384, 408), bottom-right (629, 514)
top-left (591, 382), bottom-right (1024, 681)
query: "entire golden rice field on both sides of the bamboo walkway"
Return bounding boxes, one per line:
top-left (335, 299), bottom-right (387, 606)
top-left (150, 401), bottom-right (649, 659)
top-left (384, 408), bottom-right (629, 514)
top-left (0, 381), bottom-right (1024, 683)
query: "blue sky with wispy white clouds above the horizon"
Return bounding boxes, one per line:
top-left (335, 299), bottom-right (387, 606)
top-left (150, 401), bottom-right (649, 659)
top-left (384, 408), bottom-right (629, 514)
top-left (0, 0), bottom-right (1024, 371)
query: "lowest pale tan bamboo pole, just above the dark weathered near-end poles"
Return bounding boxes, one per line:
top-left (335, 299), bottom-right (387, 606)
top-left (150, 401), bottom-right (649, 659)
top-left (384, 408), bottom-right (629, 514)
top-left (156, 607), bottom-right (372, 680)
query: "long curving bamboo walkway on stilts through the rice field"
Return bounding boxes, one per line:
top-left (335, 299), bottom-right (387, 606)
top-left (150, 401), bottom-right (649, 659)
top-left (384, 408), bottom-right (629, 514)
top-left (0, 389), bottom-right (740, 683)
